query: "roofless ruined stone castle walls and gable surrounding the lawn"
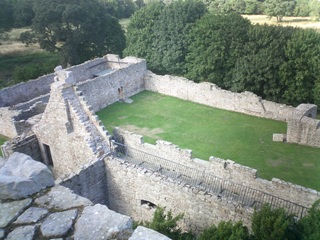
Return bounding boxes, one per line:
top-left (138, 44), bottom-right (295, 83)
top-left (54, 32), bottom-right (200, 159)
top-left (0, 55), bottom-right (320, 231)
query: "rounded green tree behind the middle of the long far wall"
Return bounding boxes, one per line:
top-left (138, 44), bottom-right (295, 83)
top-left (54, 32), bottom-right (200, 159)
top-left (186, 13), bottom-right (250, 88)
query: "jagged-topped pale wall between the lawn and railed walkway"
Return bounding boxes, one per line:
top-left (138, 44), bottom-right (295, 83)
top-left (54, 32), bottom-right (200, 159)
top-left (114, 128), bottom-right (320, 208)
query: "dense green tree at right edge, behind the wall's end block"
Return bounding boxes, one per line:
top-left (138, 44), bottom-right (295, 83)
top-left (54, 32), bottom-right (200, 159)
top-left (279, 29), bottom-right (320, 106)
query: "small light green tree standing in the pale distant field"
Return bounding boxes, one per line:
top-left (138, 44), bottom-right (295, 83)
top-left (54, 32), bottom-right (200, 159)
top-left (264, 0), bottom-right (296, 22)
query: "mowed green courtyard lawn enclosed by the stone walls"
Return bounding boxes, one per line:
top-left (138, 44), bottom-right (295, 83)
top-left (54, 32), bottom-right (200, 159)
top-left (97, 91), bottom-right (320, 190)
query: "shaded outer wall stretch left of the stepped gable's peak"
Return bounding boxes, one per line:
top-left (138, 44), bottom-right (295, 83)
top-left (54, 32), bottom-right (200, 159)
top-left (0, 74), bottom-right (54, 108)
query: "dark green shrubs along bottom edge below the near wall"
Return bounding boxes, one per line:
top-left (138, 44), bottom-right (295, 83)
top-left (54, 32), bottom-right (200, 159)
top-left (144, 200), bottom-right (320, 240)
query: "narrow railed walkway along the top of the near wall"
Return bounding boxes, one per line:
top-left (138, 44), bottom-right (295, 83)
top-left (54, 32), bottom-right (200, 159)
top-left (112, 142), bottom-right (308, 218)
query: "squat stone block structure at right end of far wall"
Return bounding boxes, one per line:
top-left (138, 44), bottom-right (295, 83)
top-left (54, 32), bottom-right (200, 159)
top-left (287, 104), bottom-right (320, 147)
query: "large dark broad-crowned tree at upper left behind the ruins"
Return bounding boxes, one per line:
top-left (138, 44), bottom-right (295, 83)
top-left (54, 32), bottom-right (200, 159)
top-left (21, 0), bottom-right (125, 65)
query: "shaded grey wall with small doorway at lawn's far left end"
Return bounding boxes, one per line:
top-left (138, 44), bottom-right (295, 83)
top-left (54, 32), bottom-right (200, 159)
top-left (77, 58), bottom-right (146, 111)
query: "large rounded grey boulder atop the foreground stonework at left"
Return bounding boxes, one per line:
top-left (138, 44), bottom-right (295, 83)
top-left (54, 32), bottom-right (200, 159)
top-left (0, 152), bottom-right (54, 199)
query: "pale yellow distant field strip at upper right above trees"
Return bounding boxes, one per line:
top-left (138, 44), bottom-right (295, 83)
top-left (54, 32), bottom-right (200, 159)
top-left (242, 15), bottom-right (320, 32)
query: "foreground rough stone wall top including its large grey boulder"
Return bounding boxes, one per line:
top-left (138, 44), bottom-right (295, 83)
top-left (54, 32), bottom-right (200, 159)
top-left (0, 152), bottom-right (169, 240)
